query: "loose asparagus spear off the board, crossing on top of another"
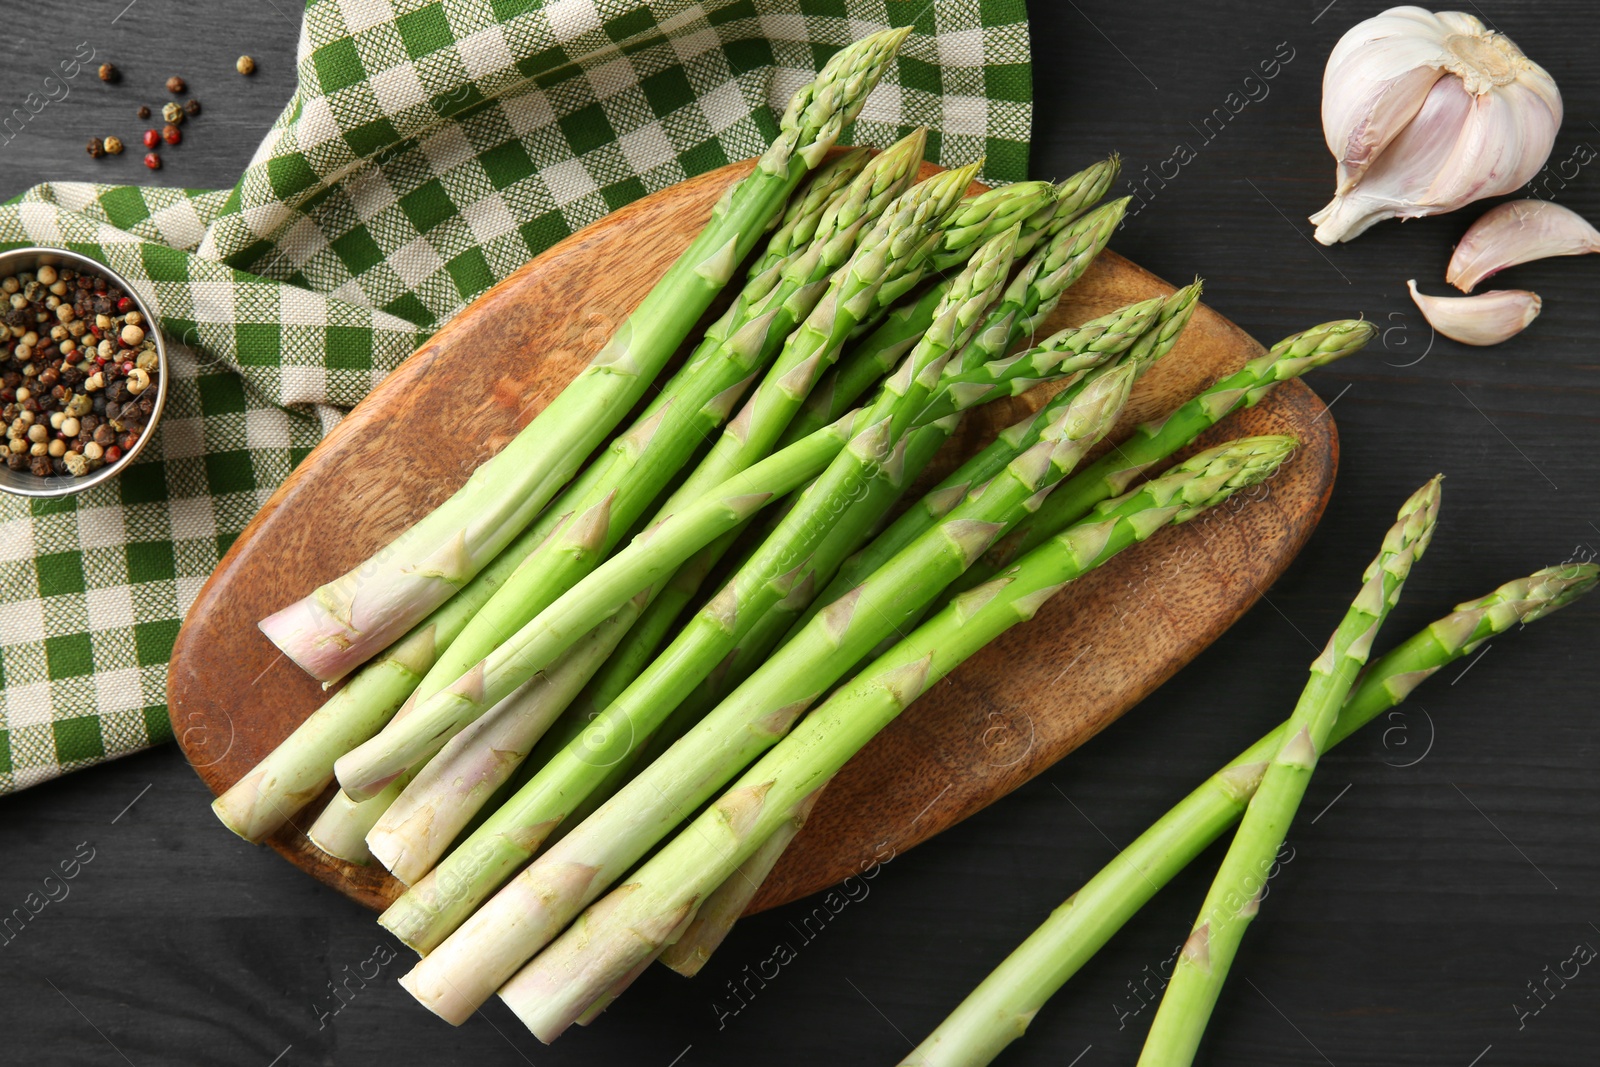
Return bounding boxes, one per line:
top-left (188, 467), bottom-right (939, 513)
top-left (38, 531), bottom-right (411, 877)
top-left (1139, 477), bottom-right (1440, 1067)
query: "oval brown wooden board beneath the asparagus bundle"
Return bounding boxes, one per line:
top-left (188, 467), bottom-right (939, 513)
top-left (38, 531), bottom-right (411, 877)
top-left (168, 151), bottom-right (1338, 909)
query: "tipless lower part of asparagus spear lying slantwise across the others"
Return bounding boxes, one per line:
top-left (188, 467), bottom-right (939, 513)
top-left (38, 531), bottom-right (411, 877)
top-left (334, 416), bottom-right (861, 800)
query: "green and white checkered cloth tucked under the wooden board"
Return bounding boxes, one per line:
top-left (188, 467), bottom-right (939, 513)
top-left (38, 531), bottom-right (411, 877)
top-left (0, 0), bottom-right (1032, 792)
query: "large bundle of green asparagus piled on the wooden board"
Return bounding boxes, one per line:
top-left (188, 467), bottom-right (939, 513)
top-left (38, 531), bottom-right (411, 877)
top-left (214, 30), bottom-right (1497, 1040)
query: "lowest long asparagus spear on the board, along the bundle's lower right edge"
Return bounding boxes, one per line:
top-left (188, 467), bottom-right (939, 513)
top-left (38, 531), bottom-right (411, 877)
top-left (489, 438), bottom-right (1293, 1041)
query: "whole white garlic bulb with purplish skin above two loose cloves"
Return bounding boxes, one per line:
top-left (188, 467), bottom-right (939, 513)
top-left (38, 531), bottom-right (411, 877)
top-left (1310, 6), bottom-right (1562, 245)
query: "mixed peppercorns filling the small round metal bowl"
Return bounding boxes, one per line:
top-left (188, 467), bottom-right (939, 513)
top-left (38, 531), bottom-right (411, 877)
top-left (0, 264), bottom-right (160, 477)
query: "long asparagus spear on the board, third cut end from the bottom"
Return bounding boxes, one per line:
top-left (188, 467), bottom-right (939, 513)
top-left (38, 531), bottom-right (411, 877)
top-left (379, 227), bottom-right (1016, 953)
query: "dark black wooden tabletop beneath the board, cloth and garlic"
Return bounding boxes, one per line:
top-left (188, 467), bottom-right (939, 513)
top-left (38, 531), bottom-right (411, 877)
top-left (0, 0), bottom-right (1600, 1067)
